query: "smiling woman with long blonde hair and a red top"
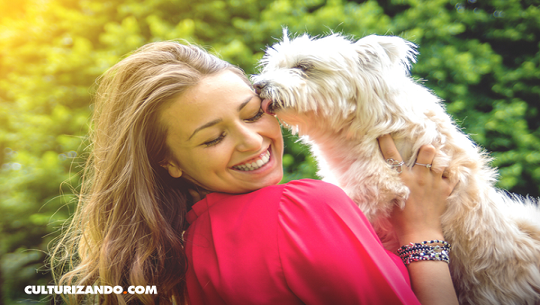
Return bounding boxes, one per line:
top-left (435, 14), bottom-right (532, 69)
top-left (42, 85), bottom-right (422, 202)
top-left (52, 42), bottom-right (457, 305)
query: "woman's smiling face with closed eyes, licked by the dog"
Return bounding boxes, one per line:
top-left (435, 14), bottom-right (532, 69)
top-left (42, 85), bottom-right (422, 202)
top-left (161, 70), bottom-right (283, 193)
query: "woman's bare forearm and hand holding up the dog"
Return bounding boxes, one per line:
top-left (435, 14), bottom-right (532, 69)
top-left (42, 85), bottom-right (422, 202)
top-left (379, 135), bottom-right (458, 305)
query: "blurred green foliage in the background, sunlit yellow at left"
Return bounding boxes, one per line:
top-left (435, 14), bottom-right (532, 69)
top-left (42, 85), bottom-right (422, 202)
top-left (0, 0), bottom-right (540, 304)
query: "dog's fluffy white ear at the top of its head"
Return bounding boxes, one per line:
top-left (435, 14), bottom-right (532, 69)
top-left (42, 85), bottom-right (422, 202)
top-left (356, 35), bottom-right (418, 71)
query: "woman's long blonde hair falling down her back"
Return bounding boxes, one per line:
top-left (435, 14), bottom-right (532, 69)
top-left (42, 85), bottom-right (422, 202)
top-left (51, 42), bottom-right (247, 304)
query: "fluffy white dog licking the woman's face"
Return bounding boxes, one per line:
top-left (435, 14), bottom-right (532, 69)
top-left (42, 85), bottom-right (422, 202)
top-left (253, 32), bottom-right (540, 305)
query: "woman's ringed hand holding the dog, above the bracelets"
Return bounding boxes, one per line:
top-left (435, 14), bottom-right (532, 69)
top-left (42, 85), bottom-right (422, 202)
top-left (379, 135), bottom-right (457, 244)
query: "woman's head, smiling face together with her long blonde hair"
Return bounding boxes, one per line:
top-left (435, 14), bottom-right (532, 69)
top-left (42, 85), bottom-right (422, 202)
top-left (51, 42), bottom-right (262, 304)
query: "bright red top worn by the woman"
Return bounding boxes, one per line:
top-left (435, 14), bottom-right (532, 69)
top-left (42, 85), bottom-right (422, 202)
top-left (185, 179), bottom-right (420, 305)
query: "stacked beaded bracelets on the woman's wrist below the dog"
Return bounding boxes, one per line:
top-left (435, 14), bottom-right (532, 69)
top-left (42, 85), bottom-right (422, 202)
top-left (397, 240), bottom-right (452, 265)
